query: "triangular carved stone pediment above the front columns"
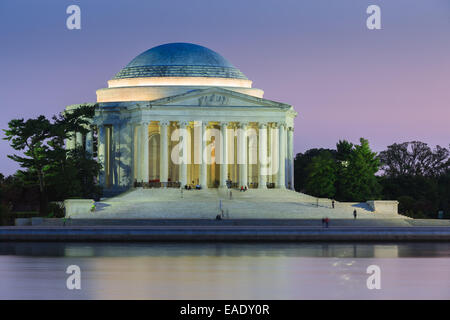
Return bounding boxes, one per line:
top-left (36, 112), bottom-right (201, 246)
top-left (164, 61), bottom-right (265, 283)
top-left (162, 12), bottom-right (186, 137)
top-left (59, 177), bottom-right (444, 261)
top-left (146, 87), bottom-right (291, 109)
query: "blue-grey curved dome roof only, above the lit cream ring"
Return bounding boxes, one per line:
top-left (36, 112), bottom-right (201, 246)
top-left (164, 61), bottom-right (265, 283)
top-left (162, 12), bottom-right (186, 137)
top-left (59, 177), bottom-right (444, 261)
top-left (114, 43), bottom-right (247, 79)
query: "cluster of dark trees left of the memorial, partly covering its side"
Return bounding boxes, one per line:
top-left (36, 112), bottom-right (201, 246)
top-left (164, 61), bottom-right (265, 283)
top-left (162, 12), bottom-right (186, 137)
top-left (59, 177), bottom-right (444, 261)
top-left (0, 105), bottom-right (101, 215)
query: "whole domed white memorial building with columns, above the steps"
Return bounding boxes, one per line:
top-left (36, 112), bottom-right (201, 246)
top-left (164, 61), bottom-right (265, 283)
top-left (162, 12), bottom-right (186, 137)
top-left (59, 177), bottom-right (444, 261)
top-left (66, 43), bottom-right (297, 192)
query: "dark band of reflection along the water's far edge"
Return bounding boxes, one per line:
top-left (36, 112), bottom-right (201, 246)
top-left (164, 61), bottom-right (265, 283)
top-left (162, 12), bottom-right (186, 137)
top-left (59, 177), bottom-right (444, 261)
top-left (0, 242), bottom-right (450, 258)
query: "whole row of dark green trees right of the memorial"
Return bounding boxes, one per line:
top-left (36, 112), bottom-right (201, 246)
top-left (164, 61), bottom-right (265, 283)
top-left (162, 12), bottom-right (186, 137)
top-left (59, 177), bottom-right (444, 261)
top-left (294, 139), bottom-right (450, 218)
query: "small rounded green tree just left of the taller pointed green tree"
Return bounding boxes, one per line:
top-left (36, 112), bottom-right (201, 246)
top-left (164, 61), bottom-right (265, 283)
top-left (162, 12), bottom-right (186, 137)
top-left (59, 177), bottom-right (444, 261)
top-left (306, 151), bottom-right (336, 198)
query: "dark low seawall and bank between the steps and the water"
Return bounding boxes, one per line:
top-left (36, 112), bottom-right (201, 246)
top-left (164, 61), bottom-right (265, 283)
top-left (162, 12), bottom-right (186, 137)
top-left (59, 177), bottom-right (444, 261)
top-left (0, 219), bottom-right (450, 242)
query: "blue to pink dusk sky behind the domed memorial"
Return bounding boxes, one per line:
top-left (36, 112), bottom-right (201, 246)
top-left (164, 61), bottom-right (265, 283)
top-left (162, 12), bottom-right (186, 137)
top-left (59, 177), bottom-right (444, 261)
top-left (0, 0), bottom-right (450, 175)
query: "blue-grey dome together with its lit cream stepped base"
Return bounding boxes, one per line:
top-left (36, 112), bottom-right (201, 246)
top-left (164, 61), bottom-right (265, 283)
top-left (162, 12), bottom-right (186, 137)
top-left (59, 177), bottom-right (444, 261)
top-left (97, 42), bottom-right (264, 102)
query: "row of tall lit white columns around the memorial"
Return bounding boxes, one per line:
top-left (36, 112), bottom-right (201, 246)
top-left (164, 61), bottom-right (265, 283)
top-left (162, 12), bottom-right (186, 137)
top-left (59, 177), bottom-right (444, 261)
top-left (92, 120), bottom-right (294, 189)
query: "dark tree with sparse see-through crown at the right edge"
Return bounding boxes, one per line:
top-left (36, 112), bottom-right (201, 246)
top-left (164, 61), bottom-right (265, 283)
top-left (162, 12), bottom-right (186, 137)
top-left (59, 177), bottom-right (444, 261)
top-left (379, 141), bottom-right (450, 218)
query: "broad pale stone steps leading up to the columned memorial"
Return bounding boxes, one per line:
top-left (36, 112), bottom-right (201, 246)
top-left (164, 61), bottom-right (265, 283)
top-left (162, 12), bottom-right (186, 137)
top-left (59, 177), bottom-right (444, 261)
top-left (67, 188), bottom-right (404, 219)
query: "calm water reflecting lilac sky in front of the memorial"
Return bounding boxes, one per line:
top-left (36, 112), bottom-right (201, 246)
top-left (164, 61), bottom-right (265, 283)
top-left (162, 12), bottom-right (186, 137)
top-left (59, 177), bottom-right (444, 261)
top-left (0, 243), bottom-right (450, 299)
